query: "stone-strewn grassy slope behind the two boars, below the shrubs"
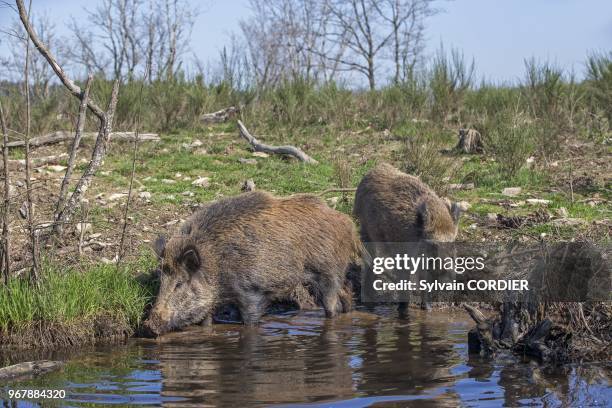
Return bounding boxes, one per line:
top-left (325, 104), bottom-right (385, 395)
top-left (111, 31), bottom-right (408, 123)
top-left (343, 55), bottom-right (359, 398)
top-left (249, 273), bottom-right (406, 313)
top-left (2, 123), bottom-right (612, 272)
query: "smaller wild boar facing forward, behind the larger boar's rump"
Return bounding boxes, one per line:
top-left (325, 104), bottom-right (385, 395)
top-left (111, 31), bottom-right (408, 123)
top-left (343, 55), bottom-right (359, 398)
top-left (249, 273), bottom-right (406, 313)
top-left (354, 163), bottom-right (460, 311)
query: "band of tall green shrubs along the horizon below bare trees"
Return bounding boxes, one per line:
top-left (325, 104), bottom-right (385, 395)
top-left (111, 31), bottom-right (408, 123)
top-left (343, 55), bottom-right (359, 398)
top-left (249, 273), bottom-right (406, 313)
top-left (0, 52), bottom-right (612, 139)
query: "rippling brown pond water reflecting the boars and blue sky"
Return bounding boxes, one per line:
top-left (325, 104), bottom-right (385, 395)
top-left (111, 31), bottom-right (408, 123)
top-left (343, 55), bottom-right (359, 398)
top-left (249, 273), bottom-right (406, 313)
top-left (0, 307), bottom-right (612, 407)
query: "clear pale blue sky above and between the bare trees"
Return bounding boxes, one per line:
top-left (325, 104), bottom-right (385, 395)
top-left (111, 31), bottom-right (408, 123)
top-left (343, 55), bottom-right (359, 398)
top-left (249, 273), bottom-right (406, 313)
top-left (0, 0), bottom-right (612, 83)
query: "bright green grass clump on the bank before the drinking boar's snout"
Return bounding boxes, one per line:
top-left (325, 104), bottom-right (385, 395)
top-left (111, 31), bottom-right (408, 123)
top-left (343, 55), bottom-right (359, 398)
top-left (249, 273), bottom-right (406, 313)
top-left (0, 257), bottom-right (155, 332)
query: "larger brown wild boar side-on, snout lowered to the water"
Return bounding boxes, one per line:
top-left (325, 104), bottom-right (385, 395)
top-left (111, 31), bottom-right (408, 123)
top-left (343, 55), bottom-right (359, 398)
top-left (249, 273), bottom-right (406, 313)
top-left (145, 192), bottom-right (360, 335)
